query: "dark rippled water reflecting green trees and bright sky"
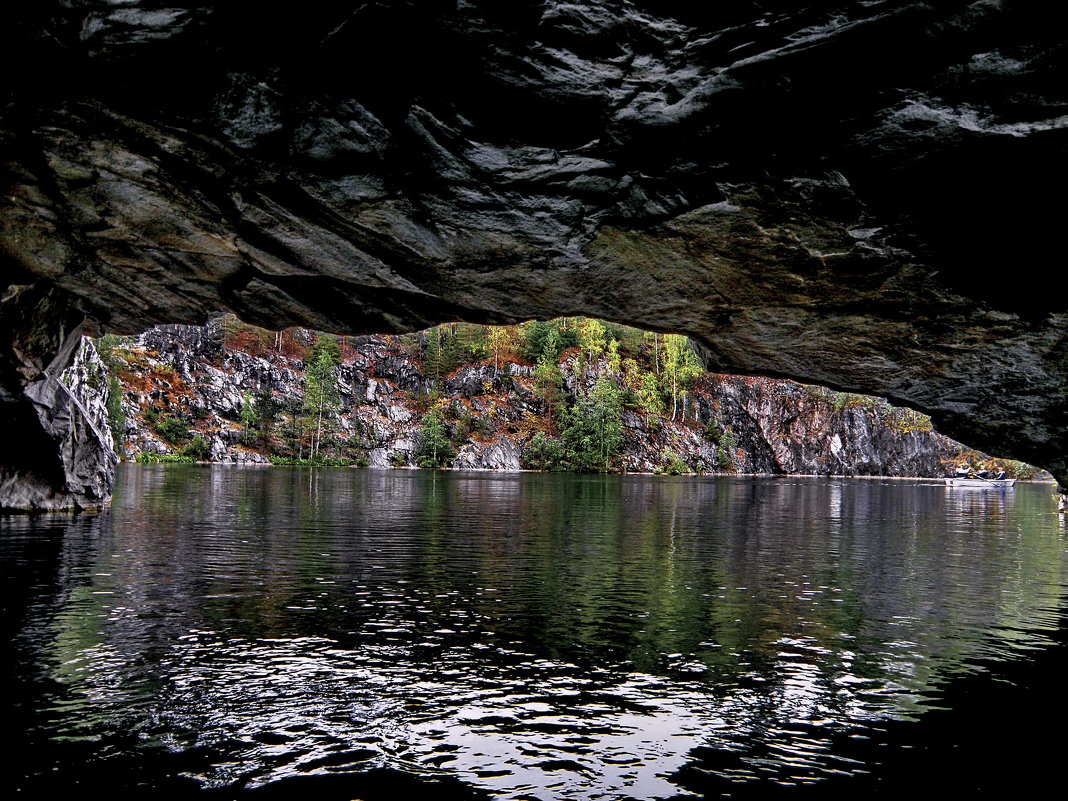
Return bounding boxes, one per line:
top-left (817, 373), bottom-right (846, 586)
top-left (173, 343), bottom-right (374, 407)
top-left (0, 466), bottom-right (1068, 801)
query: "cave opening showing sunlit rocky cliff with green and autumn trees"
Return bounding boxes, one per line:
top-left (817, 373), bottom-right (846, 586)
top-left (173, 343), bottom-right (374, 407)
top-left (58, 315), bottom-right (1038, 501)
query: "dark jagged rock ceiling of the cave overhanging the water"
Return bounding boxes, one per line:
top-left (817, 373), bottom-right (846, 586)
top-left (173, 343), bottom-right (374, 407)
top-left (0, 0), bottom-right (1068, 505)
